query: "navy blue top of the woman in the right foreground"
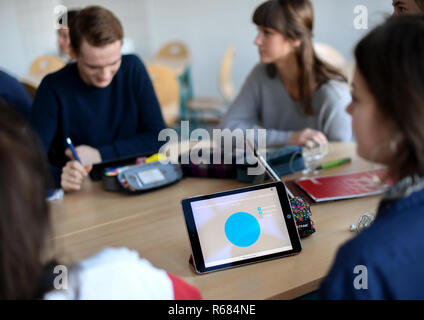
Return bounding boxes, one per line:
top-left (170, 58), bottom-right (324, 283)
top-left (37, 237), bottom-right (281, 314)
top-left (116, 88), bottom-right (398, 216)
top-left (320, 190), bottom-right (424, 300)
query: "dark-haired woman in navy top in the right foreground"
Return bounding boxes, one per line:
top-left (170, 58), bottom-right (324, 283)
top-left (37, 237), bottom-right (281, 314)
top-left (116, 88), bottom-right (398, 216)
top-left (320, 16), bottom-right (424, 299)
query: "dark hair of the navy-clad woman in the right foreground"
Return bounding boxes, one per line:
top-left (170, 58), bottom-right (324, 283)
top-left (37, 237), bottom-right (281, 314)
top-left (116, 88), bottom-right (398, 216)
top-left (355, 15), bottom-right (424, 179)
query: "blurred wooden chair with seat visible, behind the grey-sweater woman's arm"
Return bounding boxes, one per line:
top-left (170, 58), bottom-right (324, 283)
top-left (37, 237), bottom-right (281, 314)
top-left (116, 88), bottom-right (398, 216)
top-left (186, 45), bottom-right (235, 122)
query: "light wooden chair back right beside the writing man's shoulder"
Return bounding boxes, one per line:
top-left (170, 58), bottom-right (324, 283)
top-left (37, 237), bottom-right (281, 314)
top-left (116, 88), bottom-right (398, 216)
top-left (147, 64), bottom-right (180, 126)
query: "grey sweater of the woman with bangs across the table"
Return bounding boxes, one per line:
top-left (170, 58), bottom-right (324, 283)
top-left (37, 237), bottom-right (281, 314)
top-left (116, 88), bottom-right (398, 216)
top-left (221, 63), bottom-right (352, 146)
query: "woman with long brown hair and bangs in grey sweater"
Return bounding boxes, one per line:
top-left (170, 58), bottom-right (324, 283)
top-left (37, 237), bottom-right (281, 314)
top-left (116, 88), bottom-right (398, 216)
top-left (221, 0), bottom-right (351, 146)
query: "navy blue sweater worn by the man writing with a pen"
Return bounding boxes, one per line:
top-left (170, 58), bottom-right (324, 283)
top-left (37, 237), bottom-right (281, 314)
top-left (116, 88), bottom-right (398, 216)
top-left (31, 55), bottom-right (165, 185)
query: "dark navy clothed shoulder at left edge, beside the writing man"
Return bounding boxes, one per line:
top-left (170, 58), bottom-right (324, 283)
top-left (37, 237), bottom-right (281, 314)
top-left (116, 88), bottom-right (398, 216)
top-left (0, 70), bottom-right (32, 119)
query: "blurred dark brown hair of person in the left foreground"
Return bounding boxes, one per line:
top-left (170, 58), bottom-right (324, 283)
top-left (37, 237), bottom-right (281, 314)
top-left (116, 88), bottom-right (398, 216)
top-left (0, 101), bottom-right (50, 299)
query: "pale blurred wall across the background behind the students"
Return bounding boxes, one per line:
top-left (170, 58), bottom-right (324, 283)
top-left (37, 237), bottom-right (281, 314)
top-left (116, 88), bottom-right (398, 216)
top-left (0, 0), bottom-right (392, 96)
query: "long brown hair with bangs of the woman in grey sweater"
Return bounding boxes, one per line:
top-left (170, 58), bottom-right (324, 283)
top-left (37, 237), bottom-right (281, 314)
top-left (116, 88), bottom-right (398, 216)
top-left (252, 0), bottom-right (346, 115)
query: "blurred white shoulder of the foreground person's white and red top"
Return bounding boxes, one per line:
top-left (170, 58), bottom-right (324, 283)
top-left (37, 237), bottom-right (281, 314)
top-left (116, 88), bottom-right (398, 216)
top-left (45, 248), bottom-right (173, 300)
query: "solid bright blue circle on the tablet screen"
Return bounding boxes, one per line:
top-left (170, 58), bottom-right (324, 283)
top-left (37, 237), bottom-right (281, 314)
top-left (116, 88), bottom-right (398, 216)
top-left (225, 212), bottom-right (261, 247)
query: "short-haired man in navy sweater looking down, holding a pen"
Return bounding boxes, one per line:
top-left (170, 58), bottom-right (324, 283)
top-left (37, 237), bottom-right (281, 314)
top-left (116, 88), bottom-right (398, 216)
top-left (31, 6), bottom-right (165, 191)
